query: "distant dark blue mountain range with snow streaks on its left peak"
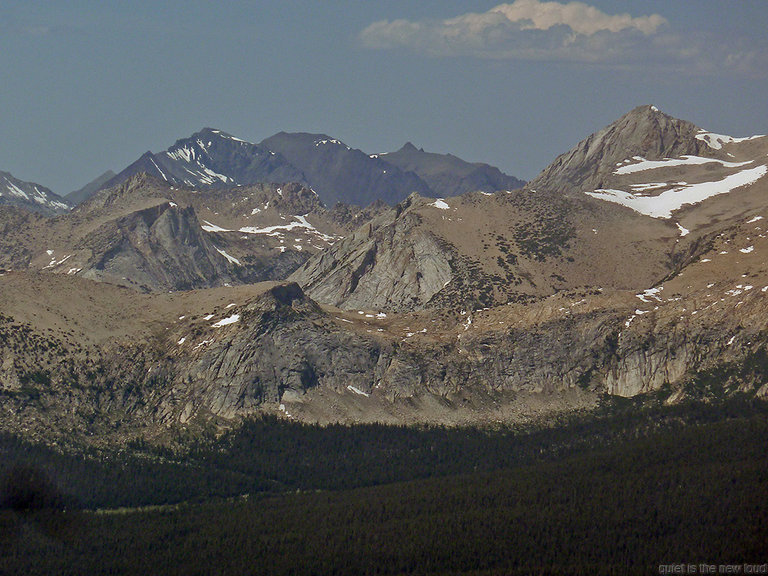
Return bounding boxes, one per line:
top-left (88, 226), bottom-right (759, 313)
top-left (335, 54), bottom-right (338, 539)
top-left (72, 128), bottom-right (522, 206)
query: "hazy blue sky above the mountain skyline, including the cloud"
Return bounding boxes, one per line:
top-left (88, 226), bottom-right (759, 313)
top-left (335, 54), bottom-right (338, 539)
top-left (0, 0), bottom-right (768, 194)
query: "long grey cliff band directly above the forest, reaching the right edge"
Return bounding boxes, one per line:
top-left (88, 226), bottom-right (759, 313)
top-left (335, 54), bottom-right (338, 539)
top-left (126, 284), bottom-right (768, 422)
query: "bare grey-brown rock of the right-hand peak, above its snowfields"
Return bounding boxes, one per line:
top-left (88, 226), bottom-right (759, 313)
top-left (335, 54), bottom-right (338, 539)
top-left (528, 106), bottom-right (712, 193)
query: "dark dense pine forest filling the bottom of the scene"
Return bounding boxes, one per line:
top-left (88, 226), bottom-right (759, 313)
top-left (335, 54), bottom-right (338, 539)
top-left (0, 398), bottom-right (768, 574)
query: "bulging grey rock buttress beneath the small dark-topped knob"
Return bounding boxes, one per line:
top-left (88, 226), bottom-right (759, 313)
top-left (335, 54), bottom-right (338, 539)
top-left (168, 283), bottom-right (378, 420)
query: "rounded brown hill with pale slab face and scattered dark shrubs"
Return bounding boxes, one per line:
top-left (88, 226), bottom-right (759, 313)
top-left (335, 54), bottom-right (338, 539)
top-left (291, 184), bottom-right (684, 311)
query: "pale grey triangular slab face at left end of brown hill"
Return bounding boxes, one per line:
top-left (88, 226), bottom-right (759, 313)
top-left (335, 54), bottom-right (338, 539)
top-left (291, 196), bottom-right (452, 310)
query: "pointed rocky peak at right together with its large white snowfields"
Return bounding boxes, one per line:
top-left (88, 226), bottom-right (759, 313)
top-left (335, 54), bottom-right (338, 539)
top-left (529, 106), bottom-right (768, 222)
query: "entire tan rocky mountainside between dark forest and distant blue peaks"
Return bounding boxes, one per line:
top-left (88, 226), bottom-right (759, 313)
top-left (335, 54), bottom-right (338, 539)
top-left (0, 107), bottom-right (768, 443)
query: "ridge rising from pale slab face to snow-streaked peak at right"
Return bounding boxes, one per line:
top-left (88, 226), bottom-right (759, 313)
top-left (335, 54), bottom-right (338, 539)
top-left (292, 106), bottom-right (768, 311)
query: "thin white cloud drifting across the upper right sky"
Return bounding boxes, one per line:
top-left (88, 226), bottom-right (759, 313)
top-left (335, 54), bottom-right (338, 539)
top-left (359, 0), bottom-right (766, 74)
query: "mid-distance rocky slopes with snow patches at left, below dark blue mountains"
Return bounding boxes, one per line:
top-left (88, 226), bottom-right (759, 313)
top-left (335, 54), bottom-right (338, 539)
top-left (0, 173), bottom-right (376, 291)
